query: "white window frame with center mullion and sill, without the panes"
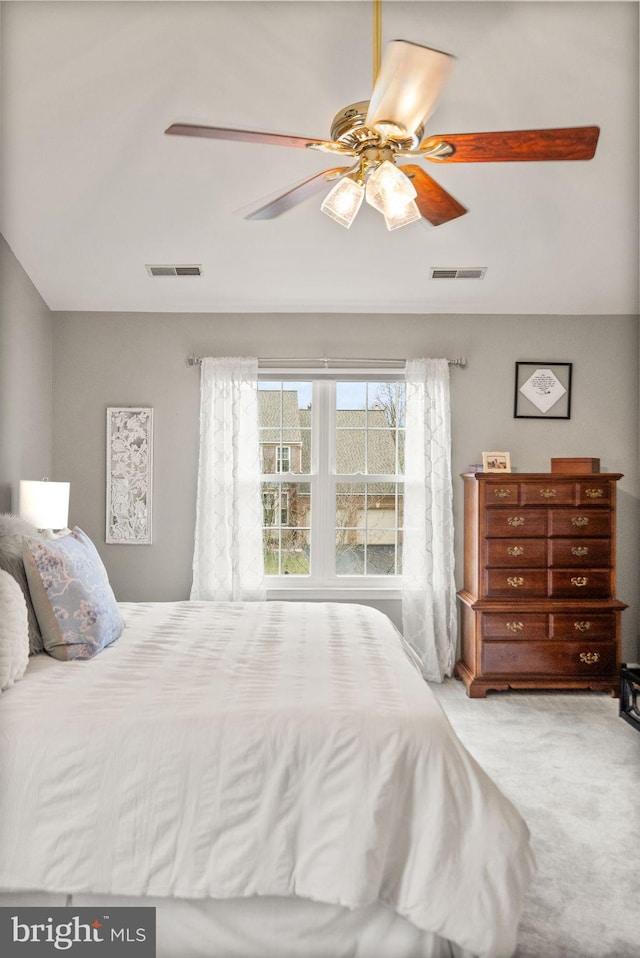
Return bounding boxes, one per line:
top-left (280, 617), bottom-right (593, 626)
top-left (259, 376), bottom-right (404, 600)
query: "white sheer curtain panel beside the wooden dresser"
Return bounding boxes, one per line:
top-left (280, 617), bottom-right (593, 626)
top-left (402, 359), bottom-right (457, 682)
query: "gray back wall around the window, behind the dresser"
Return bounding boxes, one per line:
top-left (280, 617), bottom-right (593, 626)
top-left (54, 313), bottom-right (640, 661)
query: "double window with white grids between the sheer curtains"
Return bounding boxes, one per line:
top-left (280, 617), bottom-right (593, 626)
top-left (258, 379), bottom-right (405, 589)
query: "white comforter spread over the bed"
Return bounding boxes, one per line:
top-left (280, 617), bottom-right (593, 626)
top-left (0, 602), bottom-right (533, 958)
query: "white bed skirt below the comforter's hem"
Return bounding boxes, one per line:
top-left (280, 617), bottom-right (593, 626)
top-left (0, 892), bottom-right (475, 958)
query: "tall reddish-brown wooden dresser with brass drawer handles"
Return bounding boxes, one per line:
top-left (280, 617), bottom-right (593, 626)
top-left (456, 473), bottom-right (626, 698)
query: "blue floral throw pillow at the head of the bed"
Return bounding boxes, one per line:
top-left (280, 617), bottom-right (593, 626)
top-left (23, 527), bottom-right (124, 659)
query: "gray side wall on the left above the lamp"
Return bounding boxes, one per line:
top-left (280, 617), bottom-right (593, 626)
top-left (0, 235), bottom-right (53, 512)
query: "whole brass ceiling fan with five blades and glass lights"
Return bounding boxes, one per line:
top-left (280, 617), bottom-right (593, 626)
top-left (165, 0), bottom-right (600, 229)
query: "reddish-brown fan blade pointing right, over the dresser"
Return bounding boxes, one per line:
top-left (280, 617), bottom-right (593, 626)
top-left (416, 126), bottom-right (600, 163)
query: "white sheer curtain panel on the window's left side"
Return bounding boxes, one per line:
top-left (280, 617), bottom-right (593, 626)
top-left (191, 357), bottom-right (265, 601)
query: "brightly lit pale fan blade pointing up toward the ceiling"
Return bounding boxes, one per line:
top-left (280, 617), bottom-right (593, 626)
top-left (365, 40), bottom-right (454, 136)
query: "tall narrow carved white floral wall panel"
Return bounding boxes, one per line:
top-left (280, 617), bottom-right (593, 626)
top-left (106, 406), bottom-right (153, 545)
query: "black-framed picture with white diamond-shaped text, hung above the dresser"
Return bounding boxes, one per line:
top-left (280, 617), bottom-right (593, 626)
top-left (513, 360), bottom-right (573, 419)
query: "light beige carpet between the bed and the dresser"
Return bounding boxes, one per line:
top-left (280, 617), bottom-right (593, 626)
top-left (431, 679), bottom-right (640, 958)
